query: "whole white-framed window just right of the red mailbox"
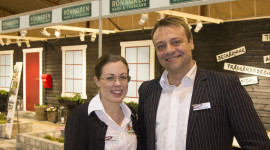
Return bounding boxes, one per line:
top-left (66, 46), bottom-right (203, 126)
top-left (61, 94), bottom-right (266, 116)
top-left (61, 45), bottom-right (87, 99)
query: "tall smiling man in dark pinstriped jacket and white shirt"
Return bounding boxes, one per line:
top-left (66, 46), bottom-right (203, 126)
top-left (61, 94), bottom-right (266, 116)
top-left (138, 17), bottom-right (270, 150)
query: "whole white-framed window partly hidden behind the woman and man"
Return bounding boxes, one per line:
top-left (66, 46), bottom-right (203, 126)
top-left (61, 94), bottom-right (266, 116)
top-left (120, 40), bottom-right (155, 102)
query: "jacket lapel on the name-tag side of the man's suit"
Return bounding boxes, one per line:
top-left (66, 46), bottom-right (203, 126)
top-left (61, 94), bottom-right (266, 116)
top-left (186, 67), bottom-right (207, 148)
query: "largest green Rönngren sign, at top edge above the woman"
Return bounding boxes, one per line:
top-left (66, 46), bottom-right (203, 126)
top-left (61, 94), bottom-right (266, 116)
top-left (110, 0), bottom-right (150, 13)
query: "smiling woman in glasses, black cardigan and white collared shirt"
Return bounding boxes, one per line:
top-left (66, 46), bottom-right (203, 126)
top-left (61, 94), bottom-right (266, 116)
top-left (64, 55), bottom-right (137, 150)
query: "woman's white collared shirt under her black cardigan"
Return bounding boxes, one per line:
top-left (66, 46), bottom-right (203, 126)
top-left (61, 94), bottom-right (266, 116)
top-left (88, 94), bottom-right (137, 150)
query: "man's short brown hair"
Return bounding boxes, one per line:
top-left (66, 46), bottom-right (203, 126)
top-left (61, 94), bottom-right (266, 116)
top-left (151, 17), bottom-right (193, 41)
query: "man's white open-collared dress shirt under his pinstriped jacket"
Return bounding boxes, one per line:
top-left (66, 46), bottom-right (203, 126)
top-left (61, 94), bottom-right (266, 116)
top-left (155, 62), bottom-right (197, 150)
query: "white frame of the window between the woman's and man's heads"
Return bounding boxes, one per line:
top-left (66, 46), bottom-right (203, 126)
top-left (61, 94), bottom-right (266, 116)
top-left (120, 40), bottom-right (155, 103)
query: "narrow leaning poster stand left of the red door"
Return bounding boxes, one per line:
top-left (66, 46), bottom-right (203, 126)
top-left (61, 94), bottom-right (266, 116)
top-left (5, 62), bottom-right (22, 138)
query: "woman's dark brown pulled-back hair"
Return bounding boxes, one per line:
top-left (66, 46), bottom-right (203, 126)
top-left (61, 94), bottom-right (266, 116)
top-left (95, 54), bottom-right (129, 79)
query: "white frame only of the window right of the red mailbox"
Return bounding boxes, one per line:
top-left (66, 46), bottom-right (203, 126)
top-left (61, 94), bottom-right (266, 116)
top-left (61, 45), bottom-right (87, 99)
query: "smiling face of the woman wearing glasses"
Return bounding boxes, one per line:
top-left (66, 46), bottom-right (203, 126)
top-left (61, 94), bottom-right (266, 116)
top-left (94, 61), bottom-right (128, 104)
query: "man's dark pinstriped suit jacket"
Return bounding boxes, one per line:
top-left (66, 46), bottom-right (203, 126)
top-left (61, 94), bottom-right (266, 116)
top-left (138, 67), bottom-right (270, 150)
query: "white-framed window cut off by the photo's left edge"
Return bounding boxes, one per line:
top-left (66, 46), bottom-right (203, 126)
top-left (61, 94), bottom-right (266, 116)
top-left (0, 50), bottom-right (14, 91)
